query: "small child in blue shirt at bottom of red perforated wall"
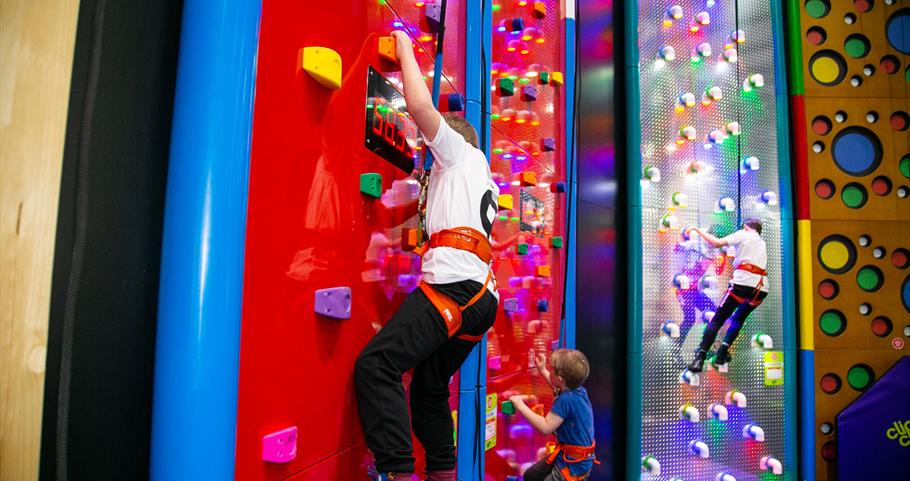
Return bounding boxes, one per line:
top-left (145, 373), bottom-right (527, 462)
top-left (509, 349), bottom-right (595, 481)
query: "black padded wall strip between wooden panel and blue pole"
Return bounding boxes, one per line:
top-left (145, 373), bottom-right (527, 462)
top-left (40, 0), bottom-right (182, 481)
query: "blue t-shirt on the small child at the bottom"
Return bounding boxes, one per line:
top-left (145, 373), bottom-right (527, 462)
top-left (550, 387), bottom-right (594, 476)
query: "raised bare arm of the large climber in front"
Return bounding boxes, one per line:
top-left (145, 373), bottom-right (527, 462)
top-left (392, 30), bottom-right (442, 142)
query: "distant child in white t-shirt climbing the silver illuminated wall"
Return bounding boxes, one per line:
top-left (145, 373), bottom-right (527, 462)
top-left (688, 218), bottom-right (768, 372)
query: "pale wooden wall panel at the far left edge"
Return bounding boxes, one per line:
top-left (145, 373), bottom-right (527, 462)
top-left (0, 0), bottom-right (79, 481)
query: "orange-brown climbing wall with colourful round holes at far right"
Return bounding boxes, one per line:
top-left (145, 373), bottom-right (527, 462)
top-left (789, 0), bottom-right (910, 480)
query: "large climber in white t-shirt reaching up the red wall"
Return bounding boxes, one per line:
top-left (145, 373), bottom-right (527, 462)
top-left (355, 31), bottom-right (499, 481)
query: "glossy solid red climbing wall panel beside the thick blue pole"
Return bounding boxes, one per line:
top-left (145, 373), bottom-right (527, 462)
top-left (235, 0), bottom-right (464, 481)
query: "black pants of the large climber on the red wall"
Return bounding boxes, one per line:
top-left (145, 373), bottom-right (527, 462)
top-left (354, 281), bottom-right (497, 473)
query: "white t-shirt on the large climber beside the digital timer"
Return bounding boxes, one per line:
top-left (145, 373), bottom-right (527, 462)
top-left (421, 119), bottom-right (499, 295)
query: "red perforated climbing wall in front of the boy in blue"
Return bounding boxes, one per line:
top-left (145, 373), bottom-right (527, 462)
top-left (486, 0), bottom-right (572, 480)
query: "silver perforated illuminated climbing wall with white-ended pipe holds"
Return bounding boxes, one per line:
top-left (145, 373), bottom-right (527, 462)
top-left (629, 0), bottom-right (796, 481)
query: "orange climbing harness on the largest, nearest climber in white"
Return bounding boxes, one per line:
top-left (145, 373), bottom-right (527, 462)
top-left (414, 227), bottom-right (495, 342)
